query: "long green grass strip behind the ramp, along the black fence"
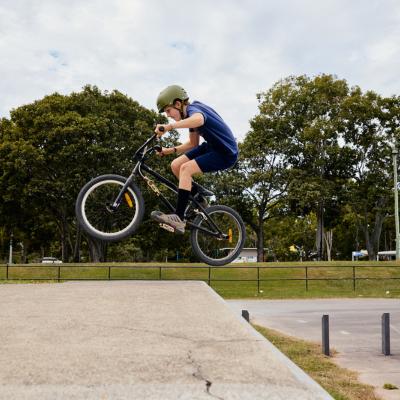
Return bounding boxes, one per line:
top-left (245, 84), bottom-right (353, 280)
top-left (0, 261), bottom-right (400, 299)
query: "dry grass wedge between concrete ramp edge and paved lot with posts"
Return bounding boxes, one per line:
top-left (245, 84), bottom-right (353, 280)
top-left (253, 325), bottom-right (380, 400)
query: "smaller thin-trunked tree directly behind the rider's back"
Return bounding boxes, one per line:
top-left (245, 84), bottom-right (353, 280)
top-left (205, 106), bottom-right (288, 262)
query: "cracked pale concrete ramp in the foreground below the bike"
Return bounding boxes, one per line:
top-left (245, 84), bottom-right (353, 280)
top-left (0, 281), bottom-right (331, 400)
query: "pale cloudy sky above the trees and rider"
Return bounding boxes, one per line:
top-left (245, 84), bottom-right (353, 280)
top-left (0, 0), bottom-right (400, 140)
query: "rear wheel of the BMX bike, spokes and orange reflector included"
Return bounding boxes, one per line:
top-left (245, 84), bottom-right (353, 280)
top-left (190, 205), bottom-right (246, 266)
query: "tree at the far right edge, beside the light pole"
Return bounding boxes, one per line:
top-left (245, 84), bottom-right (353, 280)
top-left (343, 87), bottom-right (400, 260)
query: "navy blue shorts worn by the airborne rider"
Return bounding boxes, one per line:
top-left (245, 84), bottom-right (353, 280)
top-left (185, 142), bottom-right (238, 172)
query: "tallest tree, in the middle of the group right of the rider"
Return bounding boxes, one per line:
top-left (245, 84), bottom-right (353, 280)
top-left (258, 75), bottom-right (352, 259)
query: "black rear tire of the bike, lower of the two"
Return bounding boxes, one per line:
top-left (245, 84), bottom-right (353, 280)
top-left (190, 205), bottom-right (246, 266)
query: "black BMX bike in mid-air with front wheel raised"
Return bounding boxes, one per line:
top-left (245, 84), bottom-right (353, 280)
top-left (75, 129), bottom-right (246, 266)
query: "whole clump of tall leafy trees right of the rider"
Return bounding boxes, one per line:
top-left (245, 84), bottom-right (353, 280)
top-left (214, 75), bottom-right (399, 260)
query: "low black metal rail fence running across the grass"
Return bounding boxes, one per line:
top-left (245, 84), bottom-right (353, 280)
top-left (0, 262), bottom-right (400, 291)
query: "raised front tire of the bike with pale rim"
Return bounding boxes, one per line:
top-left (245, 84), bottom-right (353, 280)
top-left (75, 174), bottom-right (145, 242)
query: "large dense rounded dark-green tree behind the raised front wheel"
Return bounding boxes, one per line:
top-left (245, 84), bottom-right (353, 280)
top-left (0, 86), bottom-right (181, 261)
